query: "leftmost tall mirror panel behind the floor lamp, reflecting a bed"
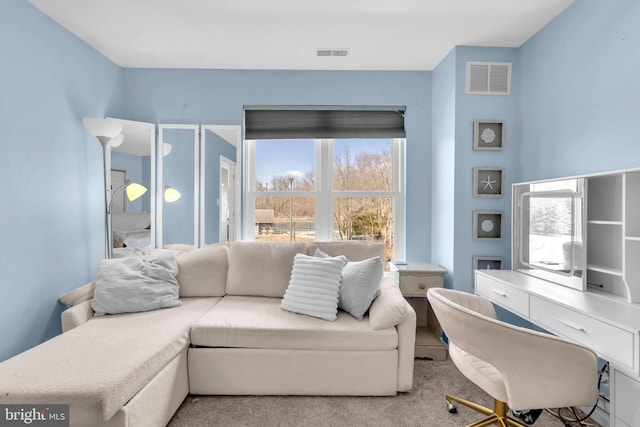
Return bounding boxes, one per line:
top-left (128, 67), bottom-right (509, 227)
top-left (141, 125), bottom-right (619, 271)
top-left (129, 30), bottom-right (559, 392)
top-left (107, 119), bottom-right (156, 257)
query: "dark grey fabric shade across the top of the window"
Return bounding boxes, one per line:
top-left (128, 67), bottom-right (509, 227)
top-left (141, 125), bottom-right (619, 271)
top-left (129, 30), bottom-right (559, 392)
top-left (244, 106), bottom-right (406, 139)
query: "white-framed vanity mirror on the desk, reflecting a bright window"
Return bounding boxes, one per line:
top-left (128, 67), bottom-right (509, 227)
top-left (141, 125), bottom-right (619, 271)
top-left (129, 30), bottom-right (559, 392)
top-left (514, 178), bottom-right (586, 289)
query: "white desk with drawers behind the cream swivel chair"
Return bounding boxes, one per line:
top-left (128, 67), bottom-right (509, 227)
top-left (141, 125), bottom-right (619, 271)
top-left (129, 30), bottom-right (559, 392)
top-left (475, 270), bottom-right (640, 427)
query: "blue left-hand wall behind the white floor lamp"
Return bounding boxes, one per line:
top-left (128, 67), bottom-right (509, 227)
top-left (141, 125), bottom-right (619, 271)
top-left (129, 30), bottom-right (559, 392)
top-left (0, 1), bottom-right (122, 360)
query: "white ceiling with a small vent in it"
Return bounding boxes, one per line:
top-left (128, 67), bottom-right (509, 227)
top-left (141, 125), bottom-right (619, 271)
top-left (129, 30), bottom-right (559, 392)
top-left (29, 0), bottom-right (574, 70)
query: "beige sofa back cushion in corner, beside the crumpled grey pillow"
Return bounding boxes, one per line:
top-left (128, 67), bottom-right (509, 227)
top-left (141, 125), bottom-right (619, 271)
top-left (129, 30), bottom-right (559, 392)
top-left (176, 245), bottom-right (229, 298)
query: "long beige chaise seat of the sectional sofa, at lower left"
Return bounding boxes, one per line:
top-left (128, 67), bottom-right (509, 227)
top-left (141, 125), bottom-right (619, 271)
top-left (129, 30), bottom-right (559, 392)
top-left (0, 298), bottom-right (220, 420)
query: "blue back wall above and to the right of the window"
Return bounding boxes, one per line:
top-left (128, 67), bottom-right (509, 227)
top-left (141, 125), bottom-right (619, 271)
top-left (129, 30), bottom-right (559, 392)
top-left (122, 69), bottom-right (431, 261)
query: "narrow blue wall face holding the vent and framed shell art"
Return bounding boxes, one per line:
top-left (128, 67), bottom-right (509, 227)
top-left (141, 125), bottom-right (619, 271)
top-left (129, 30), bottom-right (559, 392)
top-left (452, 47), bottom-right (520, 292)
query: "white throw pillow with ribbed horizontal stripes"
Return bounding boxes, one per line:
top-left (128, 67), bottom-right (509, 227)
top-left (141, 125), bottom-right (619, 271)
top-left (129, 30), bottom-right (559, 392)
top-left (281, 254), bottom-right (345, 321)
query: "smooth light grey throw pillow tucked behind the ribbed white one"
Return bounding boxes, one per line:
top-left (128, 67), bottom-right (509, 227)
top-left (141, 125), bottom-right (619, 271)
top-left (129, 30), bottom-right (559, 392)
top-left (314, 249), bottom-right (383, 320)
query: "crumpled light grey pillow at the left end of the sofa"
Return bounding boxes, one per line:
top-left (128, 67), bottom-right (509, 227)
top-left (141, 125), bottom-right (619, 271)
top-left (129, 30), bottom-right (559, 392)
top-left (91, 253), bottom-right (180, 316)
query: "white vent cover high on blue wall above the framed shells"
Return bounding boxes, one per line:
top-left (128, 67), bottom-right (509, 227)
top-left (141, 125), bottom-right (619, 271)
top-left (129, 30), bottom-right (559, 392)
top-left (465, 62), bottom-right (511, 95)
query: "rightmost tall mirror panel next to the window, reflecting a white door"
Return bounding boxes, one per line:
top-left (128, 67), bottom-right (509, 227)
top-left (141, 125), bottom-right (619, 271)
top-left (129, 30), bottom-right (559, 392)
top-left (200, 125), bottom-right (241, 246)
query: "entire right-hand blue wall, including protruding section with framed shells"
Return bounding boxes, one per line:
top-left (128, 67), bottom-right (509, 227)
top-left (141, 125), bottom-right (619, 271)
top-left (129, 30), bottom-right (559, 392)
top-left (431, 0), bottom-right (640, 291)
